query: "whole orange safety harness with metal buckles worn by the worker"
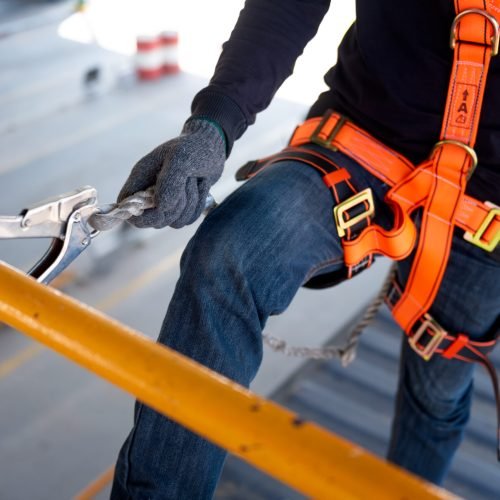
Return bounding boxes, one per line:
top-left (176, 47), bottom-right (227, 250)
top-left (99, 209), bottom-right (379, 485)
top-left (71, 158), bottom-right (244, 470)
top-left (237, 0), bottom-right (500, 460)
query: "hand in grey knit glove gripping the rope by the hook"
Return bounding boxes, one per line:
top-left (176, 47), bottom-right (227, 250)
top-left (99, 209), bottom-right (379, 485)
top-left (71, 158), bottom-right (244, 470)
top-left (118, 118), bottom-right (226, 229)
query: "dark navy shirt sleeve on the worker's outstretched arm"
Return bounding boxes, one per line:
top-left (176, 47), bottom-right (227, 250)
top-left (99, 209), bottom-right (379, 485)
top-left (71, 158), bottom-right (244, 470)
top-left (191, 0), bottom-right (330, 152)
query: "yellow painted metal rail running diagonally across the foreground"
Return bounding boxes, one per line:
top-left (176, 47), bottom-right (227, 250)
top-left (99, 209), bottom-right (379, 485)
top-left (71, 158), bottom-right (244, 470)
top-left (0, 263), bottom-right (456, 500)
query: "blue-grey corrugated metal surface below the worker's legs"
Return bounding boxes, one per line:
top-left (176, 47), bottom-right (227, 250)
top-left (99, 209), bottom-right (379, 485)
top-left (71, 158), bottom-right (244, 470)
top-left (217, 309), bottom-right (500, 500)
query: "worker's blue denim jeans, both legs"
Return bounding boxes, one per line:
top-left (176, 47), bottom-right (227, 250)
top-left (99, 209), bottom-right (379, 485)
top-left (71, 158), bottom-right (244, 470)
top-left (111, 146), bottom-right (500, 500)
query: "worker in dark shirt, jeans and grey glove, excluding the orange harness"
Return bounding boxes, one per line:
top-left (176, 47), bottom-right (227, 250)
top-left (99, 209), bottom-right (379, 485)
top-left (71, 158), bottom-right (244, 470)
top-left (112, 0), bottom-right (500, 500)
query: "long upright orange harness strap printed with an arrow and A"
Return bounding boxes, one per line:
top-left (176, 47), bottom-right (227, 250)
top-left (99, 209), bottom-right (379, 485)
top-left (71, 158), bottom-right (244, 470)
top-left (392, 0), bottom-right (498, 332)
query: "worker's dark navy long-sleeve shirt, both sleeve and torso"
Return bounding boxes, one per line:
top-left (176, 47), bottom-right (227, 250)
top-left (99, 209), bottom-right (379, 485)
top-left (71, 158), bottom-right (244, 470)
top-left (192, 0), bottom-right (500, 204)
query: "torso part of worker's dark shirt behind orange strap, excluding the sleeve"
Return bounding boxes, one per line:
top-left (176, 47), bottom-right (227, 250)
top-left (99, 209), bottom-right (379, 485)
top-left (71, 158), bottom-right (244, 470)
top-left (313, 0), bottom-right (500, 204)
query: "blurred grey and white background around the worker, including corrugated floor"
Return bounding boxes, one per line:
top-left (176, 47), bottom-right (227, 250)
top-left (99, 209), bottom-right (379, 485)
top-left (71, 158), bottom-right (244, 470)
top-left (0, 0), bottom-right (500, 500)
